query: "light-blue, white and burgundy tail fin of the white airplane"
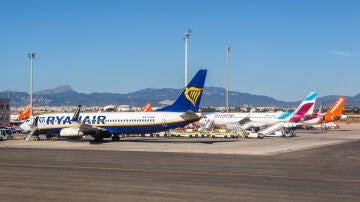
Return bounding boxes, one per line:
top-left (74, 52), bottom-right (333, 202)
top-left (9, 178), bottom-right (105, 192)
top-left (287, 92), bottom-right (317, 122)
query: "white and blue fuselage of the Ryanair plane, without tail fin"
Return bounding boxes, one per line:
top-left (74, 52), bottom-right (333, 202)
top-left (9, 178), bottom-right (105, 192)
top-left (27, 112), bottom-right (199, 135)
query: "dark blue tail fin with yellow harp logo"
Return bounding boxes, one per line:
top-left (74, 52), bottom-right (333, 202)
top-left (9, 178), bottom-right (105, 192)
top-left (157, 69), bottom-right (207, 112)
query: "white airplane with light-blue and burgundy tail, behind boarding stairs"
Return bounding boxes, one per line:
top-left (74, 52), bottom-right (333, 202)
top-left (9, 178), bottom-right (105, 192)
top-left (199, 92), bottom-right (317, 130)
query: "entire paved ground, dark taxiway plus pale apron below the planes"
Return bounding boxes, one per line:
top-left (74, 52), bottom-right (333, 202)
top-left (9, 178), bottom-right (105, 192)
top-left (0, 123), bottom-right (360, 202)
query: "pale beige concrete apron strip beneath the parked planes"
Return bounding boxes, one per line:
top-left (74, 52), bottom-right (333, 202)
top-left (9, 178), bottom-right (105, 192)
top-left (0, 123), bottom-right (360, 155)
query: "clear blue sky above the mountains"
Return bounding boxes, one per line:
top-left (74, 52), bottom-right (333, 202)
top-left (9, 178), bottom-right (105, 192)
top-left (0, 0), bottom-right (360, 101)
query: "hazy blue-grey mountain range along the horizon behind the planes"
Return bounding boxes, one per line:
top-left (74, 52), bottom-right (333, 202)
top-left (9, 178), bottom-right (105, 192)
top-left (0, 85), bottom-right (360, 107)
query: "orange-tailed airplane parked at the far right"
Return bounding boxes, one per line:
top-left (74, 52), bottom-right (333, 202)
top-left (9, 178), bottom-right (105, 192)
top-left (299, 96), bottom-right (346, 128)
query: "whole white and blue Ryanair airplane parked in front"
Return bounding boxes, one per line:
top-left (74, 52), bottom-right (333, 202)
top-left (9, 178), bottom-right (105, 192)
top-left (20, 69), bottom-right (207, 142)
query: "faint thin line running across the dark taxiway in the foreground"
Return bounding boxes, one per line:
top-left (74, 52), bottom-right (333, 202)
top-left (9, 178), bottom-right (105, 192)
top-left (0, 163), bottom-right (360, 183)
